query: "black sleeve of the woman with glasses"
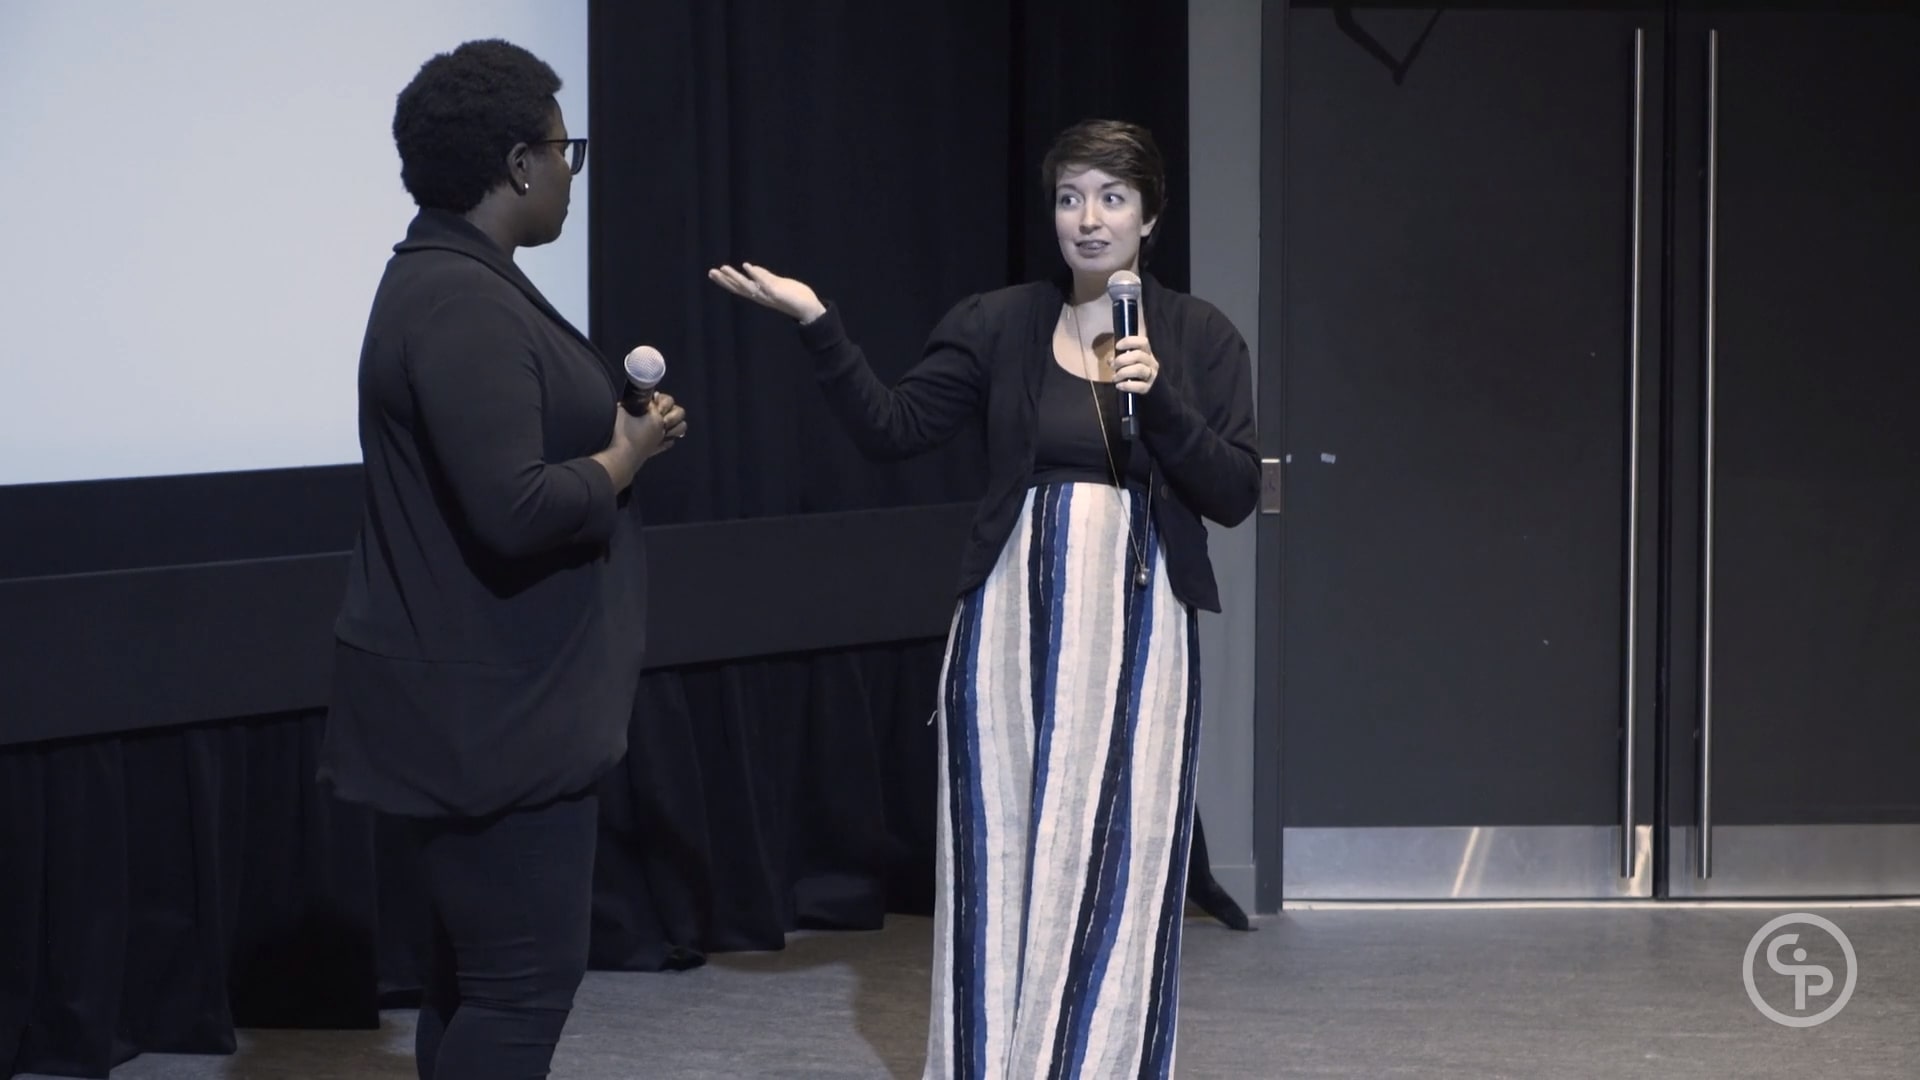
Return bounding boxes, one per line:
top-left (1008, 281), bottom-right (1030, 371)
top-left (407, 296), bottom-right (614, 557)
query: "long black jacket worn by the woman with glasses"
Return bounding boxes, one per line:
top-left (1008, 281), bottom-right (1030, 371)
top-left (321, 211), bottom-right (647, 815)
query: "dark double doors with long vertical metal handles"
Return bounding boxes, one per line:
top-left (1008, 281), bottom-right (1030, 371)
top-left (1261, 4), bottom-right (1920, 899)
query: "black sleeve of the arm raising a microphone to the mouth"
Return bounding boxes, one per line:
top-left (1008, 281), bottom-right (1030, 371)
top-left (1139, 299), bottom-right (1260, 528)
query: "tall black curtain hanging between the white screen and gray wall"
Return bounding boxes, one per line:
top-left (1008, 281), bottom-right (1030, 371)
top-left (589, 0), bottom-right (1187, 523)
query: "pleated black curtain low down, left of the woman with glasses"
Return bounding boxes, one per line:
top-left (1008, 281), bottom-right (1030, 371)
top-left (0, 711), bottom-right (378, 1076)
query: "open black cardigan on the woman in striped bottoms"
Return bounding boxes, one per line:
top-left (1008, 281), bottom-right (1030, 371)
top-left (801, 275), bottom-right (1260, 611)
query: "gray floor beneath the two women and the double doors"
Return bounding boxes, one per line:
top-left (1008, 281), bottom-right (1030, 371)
top-left (33, 907), bottom-right (1920, 1080)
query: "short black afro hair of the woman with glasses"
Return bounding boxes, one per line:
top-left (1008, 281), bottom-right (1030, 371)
top-left (394, 38), bottom-right (561, 213)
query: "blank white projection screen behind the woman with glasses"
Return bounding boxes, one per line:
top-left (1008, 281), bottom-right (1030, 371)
top-left (0, 0), bottom-right (593, 484)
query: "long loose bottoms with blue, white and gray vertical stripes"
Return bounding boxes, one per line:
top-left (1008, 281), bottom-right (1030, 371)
top-left (925, 482), bottom-right (1200, 1080)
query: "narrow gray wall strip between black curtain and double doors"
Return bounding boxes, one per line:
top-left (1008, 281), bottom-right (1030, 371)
top-left (1185, 0), bottom-right (1260, 913)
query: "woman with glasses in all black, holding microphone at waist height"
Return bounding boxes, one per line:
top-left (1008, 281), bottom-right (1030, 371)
top-left (321, 40), bottom-right (685, 1080)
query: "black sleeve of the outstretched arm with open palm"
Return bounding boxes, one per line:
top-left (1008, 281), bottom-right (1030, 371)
top-left (801, 296), bottom-right (991, 461)
